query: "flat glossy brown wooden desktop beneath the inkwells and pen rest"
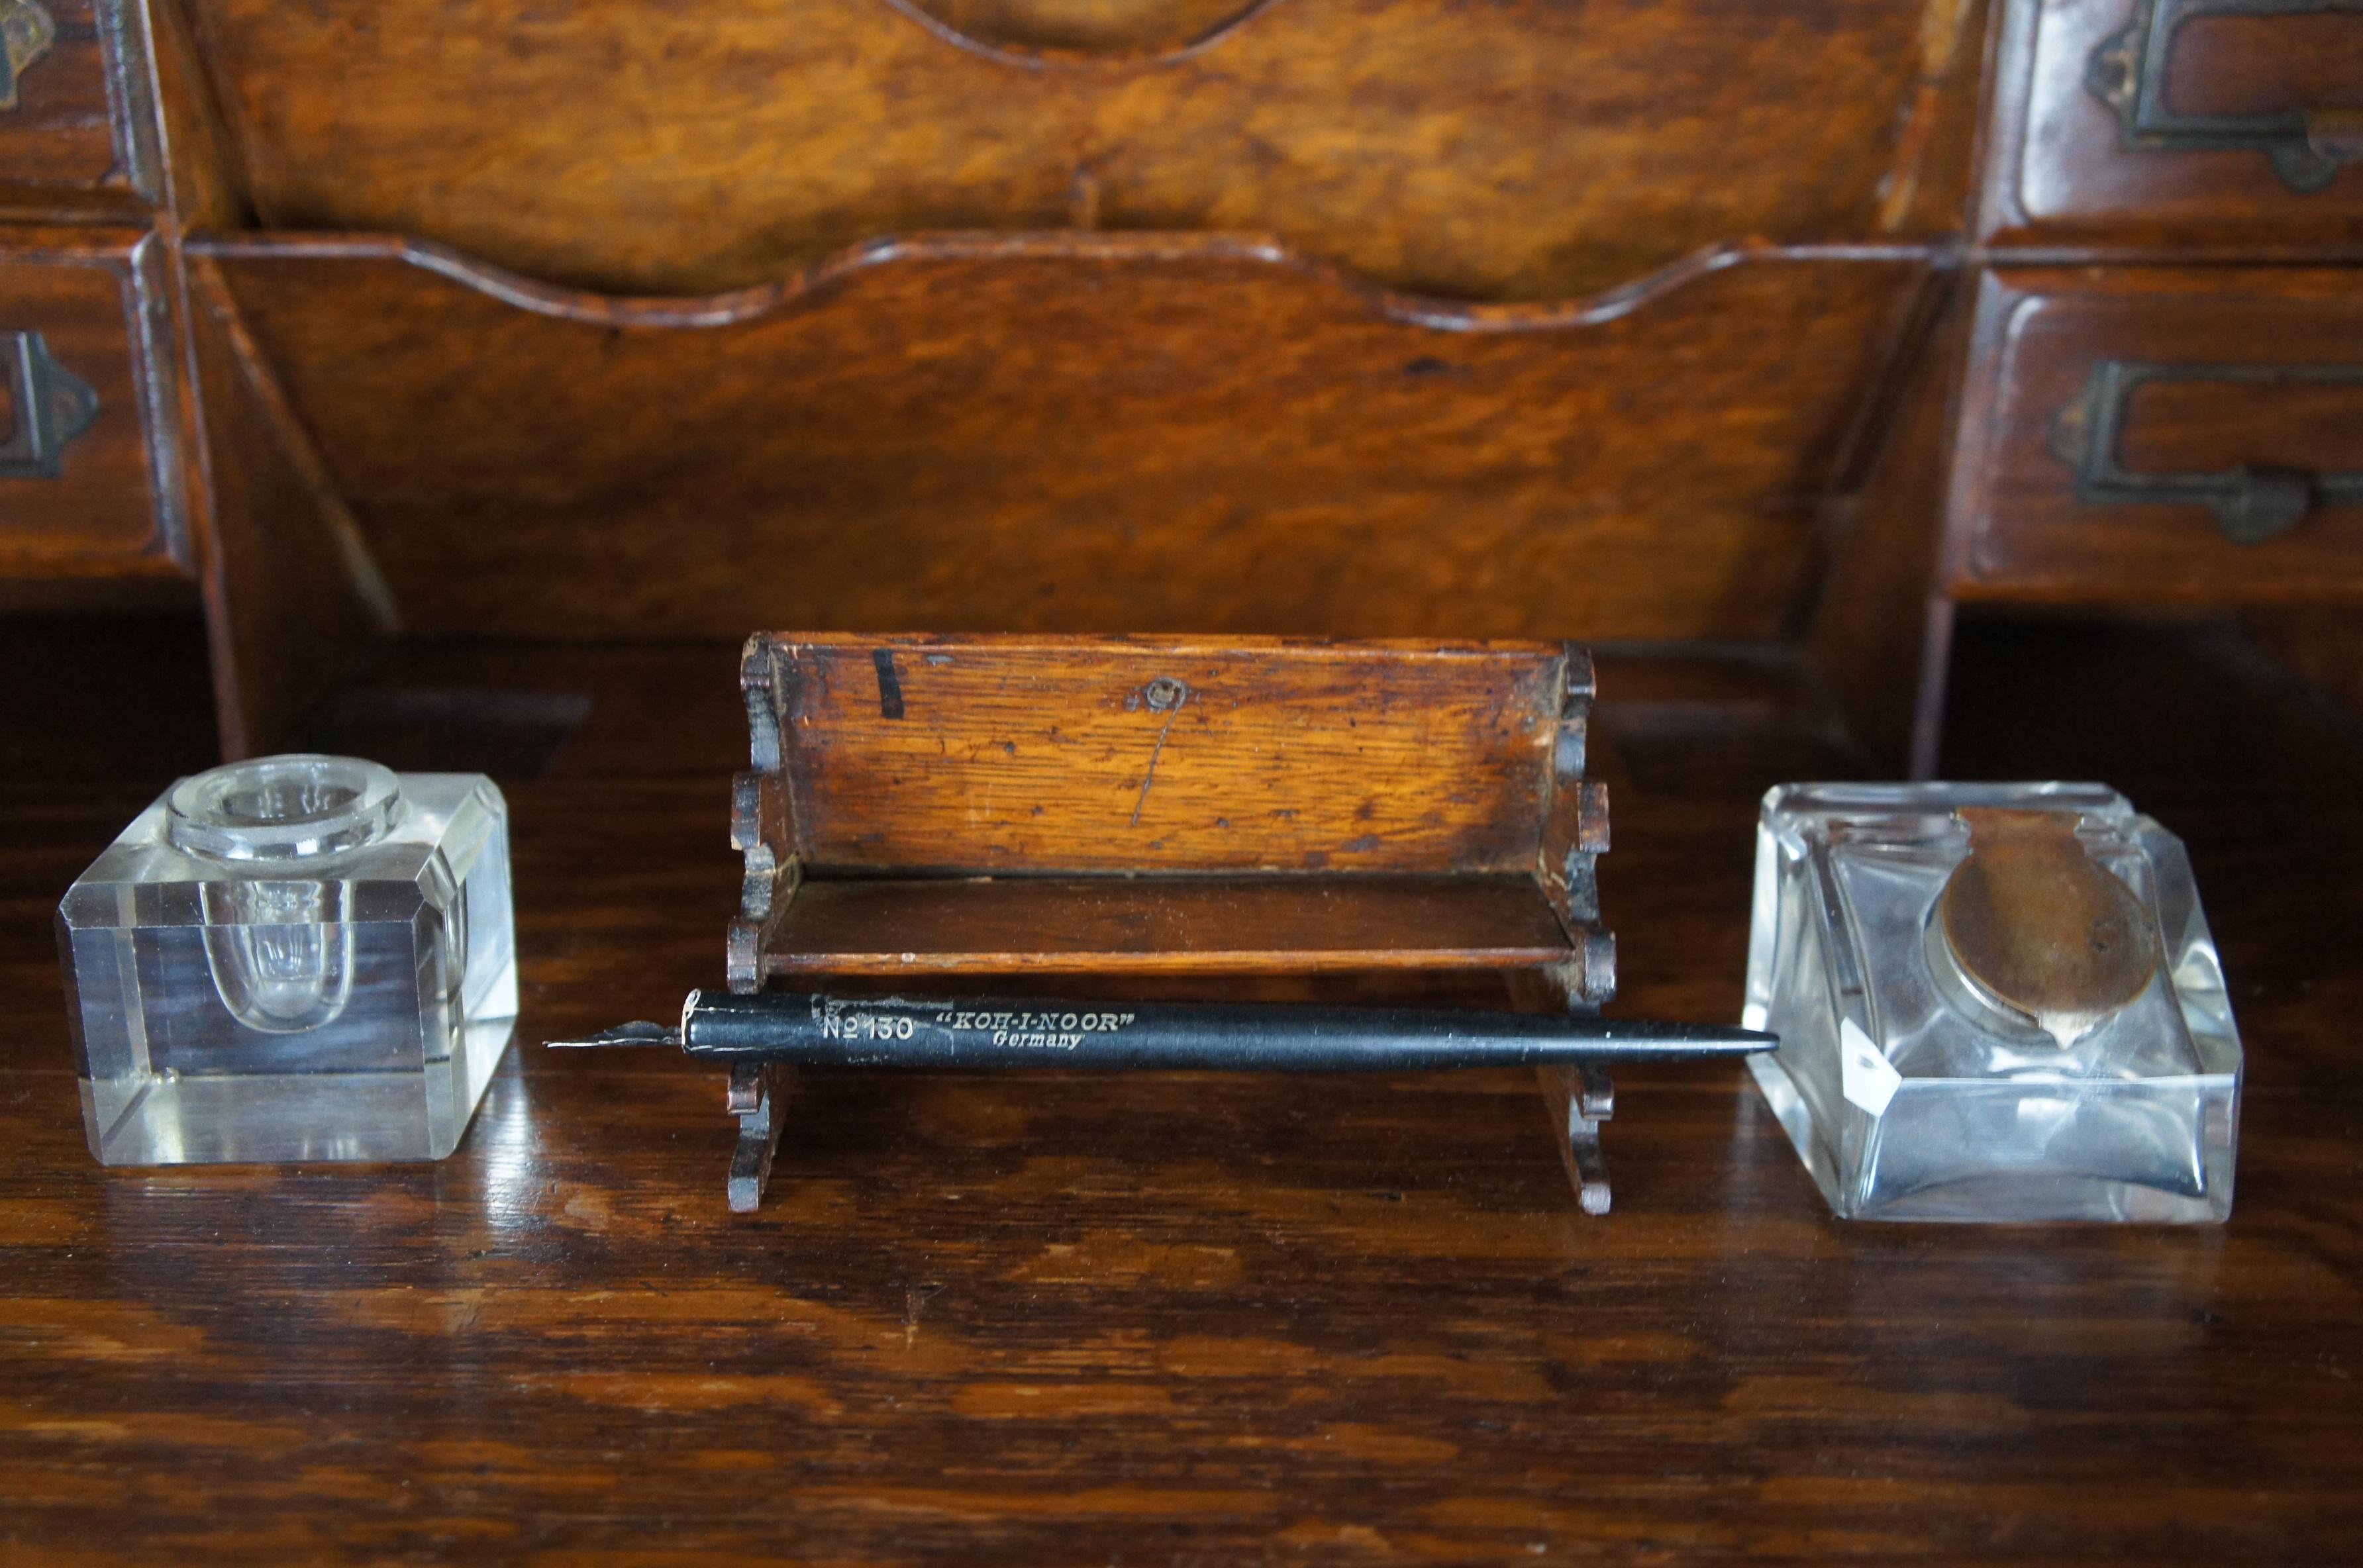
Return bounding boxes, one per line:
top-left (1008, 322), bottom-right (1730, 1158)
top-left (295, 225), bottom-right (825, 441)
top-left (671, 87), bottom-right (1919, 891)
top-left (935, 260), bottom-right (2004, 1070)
top-left (0, 621), bottom-right (2363, 1565)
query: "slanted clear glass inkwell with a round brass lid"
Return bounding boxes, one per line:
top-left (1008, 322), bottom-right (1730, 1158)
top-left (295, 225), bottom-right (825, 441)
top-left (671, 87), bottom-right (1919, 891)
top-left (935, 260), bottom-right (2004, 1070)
top-left (1744, 784), bottom-right (2240, 1221)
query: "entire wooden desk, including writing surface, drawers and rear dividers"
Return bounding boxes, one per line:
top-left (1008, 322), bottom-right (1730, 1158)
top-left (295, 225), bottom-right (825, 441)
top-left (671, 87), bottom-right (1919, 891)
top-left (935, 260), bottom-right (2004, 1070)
top-left (0, 0), bottom-right (2363, 1563)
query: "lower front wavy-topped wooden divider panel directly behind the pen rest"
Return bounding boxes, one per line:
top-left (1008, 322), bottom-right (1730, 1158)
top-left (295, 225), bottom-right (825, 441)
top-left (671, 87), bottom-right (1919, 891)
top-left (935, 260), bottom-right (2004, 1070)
top-left (203, 236), bottom-right (1923, 638)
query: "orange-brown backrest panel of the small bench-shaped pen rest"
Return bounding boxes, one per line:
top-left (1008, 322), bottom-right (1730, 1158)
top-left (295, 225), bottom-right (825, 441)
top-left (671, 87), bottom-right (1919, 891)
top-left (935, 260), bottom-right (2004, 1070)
top-left (749, 633), bottom-right (1564, 874)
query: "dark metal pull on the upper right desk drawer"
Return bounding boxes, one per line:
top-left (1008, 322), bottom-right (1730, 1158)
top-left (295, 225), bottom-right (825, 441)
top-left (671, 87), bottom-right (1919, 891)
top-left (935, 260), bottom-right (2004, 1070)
top-left (2084, 0), bottom-right (2363, 193)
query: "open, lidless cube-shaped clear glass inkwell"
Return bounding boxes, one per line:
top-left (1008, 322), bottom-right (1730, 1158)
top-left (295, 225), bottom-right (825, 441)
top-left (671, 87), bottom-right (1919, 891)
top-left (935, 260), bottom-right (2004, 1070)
top-left (57, 756), bottom-right (517, 1164)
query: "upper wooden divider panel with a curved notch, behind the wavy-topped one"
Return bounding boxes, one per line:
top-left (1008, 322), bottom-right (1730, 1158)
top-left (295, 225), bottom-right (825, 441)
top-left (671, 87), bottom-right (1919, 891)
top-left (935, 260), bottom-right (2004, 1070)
top-left (196, 0), bottom-right (1971, 300)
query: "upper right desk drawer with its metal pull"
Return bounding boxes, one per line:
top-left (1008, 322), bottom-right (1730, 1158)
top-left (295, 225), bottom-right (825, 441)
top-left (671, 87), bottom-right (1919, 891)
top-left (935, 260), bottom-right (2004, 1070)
top-left (1983, 0), bottom-right (2363, 253)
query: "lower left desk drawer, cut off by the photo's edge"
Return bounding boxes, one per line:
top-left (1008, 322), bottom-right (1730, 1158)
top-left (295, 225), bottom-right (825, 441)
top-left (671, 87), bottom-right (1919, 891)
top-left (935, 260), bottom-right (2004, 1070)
top-left (0, 229), bottom-right (187, 579)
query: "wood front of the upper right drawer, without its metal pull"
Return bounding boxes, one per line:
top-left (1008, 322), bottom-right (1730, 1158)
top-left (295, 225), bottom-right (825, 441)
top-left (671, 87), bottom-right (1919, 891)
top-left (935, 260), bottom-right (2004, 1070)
top-left (1980, 0), bottom-right (2363, 255)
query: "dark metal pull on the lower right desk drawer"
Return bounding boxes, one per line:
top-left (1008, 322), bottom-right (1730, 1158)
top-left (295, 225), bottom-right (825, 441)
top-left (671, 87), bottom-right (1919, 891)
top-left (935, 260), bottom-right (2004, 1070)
top-left (2051, 359), bottom-right (2363, 546)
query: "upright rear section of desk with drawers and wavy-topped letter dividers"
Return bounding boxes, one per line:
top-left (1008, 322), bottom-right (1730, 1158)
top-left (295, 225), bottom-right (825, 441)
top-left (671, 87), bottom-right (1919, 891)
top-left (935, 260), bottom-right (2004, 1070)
top-left (0, 0), bottom-right (2363, 772)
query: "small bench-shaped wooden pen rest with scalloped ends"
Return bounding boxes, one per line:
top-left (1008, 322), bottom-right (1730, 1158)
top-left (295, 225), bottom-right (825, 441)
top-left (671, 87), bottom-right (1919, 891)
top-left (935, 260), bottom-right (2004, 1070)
top-left (728, 633), bottom-right (1614, 1214)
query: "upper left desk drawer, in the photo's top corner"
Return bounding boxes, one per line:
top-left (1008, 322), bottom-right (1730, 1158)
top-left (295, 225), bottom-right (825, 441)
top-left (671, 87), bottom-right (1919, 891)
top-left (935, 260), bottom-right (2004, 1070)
top-left (0, 0), bottom-right (156, 199)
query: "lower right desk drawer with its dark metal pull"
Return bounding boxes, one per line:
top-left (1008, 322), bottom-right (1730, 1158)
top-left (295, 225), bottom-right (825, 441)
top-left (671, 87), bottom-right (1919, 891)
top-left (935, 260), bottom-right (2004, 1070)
top-left (1952, 267), bottom-right (2363, 602)
